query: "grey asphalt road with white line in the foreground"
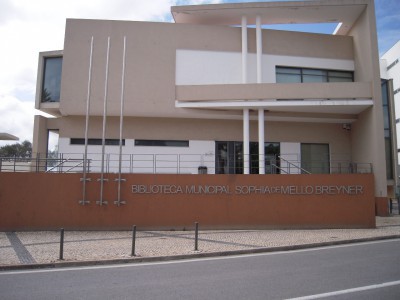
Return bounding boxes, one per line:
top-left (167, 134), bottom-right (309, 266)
top-left (0, 240), bottom-right (400, 300)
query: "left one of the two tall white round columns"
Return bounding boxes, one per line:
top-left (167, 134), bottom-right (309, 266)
top-left (242, 16), bottom-right (250, 174)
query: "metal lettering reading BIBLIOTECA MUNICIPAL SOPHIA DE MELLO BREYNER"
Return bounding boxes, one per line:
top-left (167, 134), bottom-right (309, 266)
top-left (131, 184), bottom-right (364, 195)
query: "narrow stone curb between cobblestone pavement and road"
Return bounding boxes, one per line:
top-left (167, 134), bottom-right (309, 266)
top-left (0, 234), bottom-right (400, 271)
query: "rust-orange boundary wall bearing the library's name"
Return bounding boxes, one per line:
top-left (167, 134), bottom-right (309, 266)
top-left (0, 173), bottom-right (375, 231)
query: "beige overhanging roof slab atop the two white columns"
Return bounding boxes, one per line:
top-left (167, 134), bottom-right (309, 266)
top-left (171, 0), bottom-right (369, 35)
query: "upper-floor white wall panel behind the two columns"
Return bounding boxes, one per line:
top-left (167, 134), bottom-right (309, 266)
top-left (175, 49), bottom-right (354, 85)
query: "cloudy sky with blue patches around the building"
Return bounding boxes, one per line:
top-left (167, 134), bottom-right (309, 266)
top-left (0, 0), bottom-right (400, 146)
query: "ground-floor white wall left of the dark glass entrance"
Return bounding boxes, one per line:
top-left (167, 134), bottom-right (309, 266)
top-left (55, 138), bottom-right (215, 174)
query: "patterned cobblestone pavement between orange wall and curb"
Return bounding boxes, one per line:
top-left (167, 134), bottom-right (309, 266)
top-left (0, 215), bottom-right (400, 267)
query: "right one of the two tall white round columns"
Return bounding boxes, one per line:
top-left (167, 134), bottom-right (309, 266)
top-left (256, 16), bottom-right (265, 174)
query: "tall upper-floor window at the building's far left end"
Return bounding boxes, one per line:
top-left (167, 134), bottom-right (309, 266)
top-left (41, 57), bottom-right (62, 102)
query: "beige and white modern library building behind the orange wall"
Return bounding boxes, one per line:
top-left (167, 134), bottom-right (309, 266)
top-left (33, 0), bottom-right (395, 214)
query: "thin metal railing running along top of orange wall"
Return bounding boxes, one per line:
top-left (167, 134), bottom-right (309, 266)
top-left (0, 153), bottom-right (373, 174)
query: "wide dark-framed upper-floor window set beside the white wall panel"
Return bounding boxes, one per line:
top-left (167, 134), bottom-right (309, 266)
top-left (276, 66), bottom-right (354, 83)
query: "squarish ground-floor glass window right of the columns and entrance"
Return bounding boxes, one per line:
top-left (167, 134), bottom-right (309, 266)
top-left (301, 144), bottom-right (330, 174)
